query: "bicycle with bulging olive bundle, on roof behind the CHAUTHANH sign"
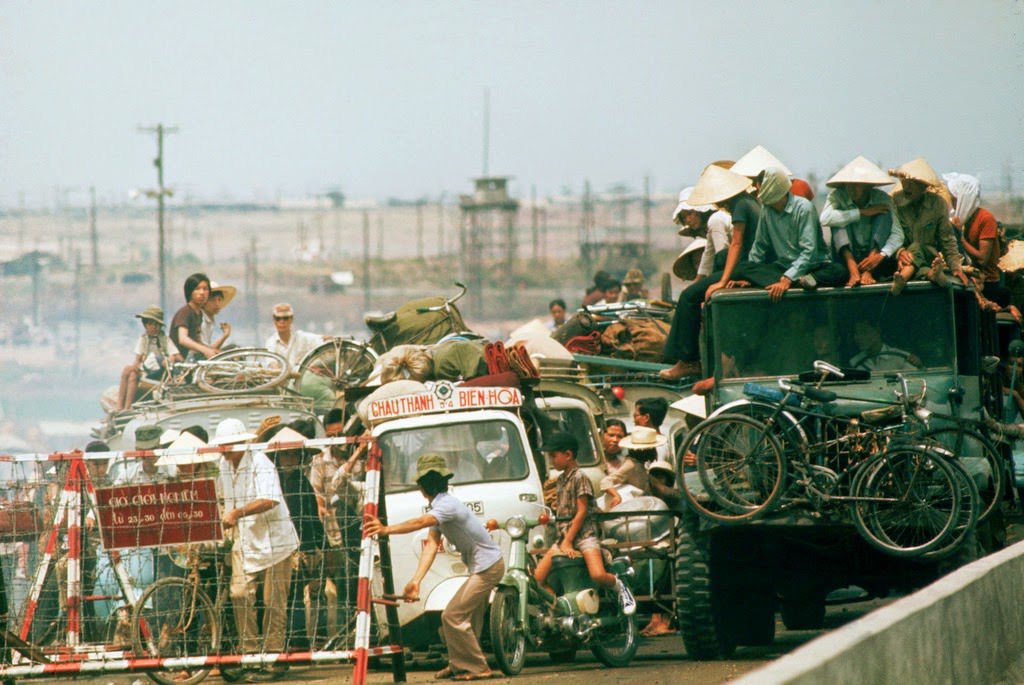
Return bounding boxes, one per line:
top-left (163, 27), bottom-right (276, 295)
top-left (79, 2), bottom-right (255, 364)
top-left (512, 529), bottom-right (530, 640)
top-left (296, 282), bottom-right (466, 394)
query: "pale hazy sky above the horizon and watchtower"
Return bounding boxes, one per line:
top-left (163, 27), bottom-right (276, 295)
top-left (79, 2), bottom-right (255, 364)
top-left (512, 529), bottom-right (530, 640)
top-left (0, 0), bottom-right (1024, 206)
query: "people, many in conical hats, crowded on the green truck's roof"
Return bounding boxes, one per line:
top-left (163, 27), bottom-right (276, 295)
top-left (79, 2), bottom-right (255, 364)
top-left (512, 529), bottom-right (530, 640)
top-left (553, 145), bottom-right (1021, 380)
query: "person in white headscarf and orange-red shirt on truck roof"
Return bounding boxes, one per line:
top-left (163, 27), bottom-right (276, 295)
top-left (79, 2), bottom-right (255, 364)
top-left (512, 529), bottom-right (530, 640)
top-left (942, 173), bottom-right (1010, 307)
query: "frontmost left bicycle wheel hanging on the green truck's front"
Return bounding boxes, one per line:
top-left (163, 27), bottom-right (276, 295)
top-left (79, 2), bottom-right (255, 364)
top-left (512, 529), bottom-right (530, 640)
top-left (680, 414), bottom-right (785, 522)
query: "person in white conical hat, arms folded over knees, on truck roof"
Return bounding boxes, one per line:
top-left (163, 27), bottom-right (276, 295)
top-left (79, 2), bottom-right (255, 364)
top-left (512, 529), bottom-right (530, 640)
top-left (821, 156), bottom-right (903, 288)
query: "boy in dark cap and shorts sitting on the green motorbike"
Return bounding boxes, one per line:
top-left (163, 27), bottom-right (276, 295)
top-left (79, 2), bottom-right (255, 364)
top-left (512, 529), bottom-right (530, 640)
top-left (534, 432), bottom-right (637, 615)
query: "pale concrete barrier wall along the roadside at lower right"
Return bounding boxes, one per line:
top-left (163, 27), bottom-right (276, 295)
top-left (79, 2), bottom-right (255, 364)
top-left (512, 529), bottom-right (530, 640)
top-left (733, 542), bottom-right (1024, 685)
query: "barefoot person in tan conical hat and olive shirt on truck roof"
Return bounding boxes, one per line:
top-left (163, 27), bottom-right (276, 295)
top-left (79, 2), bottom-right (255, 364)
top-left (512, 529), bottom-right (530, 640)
top-left (889, 157), bottom-right (967, 295)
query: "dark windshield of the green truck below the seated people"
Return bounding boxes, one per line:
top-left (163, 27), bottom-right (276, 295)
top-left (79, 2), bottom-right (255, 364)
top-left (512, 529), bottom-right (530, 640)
top-left (708, 289), bottom-right (956, 380)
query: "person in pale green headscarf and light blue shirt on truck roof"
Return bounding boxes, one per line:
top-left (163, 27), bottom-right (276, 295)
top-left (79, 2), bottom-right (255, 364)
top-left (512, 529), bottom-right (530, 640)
top-left (735, 167), bottom-right (846, 302)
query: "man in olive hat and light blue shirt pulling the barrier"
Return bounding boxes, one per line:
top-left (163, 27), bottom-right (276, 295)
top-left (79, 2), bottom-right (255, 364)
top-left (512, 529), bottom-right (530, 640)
top-left (362, 454), bottom-right (505, 680)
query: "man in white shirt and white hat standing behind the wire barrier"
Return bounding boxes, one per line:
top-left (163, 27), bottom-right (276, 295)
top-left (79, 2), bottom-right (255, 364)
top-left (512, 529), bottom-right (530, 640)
top-left (210, 419), bottom-right (299, 652)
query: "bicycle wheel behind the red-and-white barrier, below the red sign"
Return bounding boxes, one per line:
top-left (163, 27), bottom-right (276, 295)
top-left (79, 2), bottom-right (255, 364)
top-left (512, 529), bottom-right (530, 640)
top-left (131, 577), bottom-right (220, 685)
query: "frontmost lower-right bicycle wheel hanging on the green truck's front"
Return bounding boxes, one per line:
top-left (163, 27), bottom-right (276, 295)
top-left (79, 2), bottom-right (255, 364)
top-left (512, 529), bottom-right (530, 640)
top-left (851, 446), bottom-right (961, 557)
